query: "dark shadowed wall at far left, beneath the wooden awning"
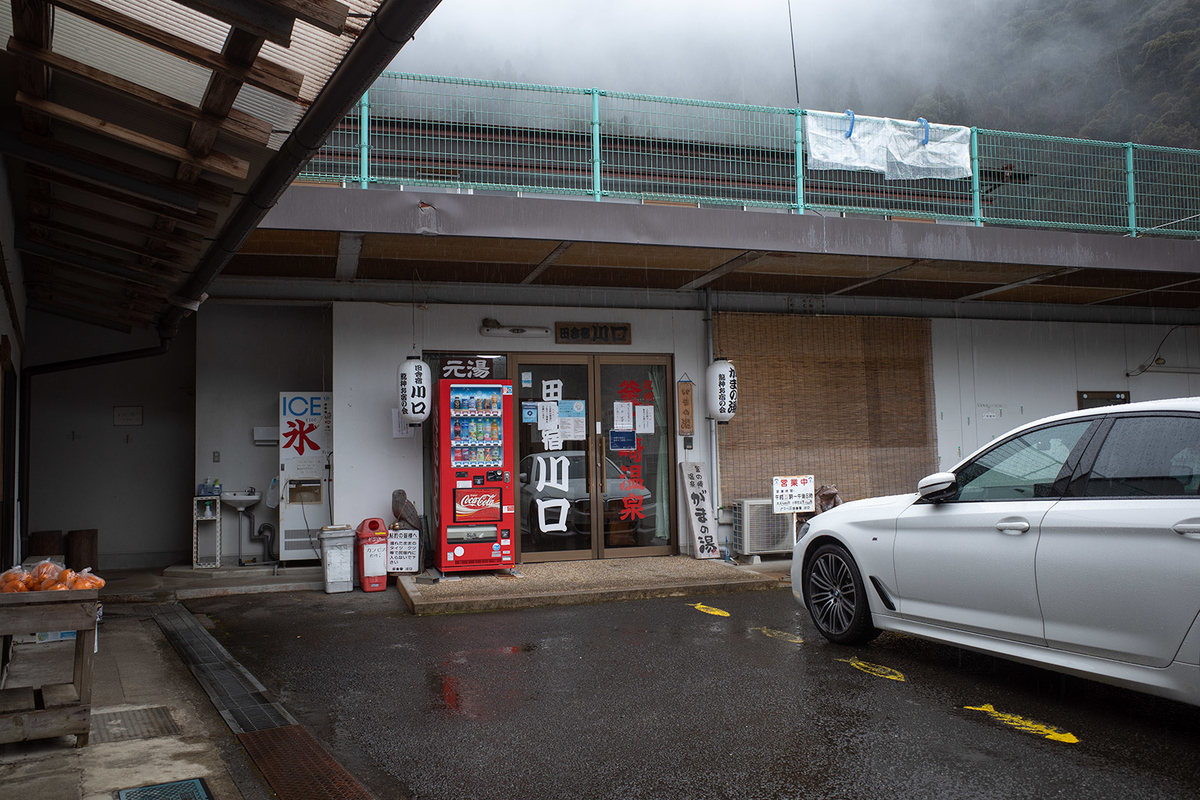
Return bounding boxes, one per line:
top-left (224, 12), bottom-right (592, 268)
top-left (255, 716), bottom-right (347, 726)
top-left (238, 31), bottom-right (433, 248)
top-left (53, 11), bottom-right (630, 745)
top-left (26, 311), bottom-right (196, 571)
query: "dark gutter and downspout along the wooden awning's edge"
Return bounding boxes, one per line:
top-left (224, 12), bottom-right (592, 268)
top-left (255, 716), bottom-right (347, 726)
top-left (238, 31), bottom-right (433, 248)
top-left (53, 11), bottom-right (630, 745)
top-left (18, 0), bottom-right (440, 540)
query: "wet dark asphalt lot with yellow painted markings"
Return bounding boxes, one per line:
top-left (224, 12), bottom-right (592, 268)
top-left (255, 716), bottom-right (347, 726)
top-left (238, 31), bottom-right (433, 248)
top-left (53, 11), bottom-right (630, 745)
top-left (187, 590), bottom-right (1200, 800)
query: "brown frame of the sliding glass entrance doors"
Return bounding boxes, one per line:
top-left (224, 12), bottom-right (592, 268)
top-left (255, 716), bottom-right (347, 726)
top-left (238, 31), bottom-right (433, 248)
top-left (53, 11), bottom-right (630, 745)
top-left (508, 351), bottom-right (679, 564)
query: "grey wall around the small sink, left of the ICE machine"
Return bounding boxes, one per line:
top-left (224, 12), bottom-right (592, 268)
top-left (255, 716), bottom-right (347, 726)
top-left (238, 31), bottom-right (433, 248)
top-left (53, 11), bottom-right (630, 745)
top-left (195, 302), bottom-right (331, 564)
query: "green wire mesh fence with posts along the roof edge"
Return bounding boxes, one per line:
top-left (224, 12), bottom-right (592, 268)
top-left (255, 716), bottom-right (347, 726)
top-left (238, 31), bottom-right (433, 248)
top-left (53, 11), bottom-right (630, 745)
top-left (299, 73), bottom-right (1200, 237)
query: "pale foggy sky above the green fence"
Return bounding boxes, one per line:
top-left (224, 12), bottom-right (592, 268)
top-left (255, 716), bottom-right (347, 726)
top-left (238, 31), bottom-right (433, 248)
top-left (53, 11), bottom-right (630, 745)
top-left (390, 0), bottom-right (998, 122)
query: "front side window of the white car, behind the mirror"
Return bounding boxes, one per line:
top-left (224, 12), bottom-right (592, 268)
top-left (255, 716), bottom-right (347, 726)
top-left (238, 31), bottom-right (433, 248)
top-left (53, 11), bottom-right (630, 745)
top-left (954, 420), bottom-right (1092, 503)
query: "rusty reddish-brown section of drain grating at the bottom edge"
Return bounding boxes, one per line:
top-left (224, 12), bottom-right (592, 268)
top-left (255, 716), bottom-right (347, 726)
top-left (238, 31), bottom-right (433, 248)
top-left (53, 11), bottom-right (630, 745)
top-left (238, 726), bottom-right (372, 800)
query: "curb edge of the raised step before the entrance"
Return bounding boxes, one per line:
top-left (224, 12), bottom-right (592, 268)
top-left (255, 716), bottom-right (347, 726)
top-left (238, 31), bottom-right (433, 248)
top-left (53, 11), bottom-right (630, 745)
top-left (396, 576), bottom-right (782, 616)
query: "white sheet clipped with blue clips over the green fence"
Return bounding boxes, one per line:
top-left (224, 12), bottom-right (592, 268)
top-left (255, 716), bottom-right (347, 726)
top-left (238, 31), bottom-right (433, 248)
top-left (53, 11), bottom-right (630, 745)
top-left (805, 112), bottom-right (971, 180)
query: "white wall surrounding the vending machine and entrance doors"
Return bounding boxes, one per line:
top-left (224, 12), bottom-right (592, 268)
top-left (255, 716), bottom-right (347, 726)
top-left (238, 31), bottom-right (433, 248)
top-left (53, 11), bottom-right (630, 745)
top-left (334, 303), bottom-right (712, 545)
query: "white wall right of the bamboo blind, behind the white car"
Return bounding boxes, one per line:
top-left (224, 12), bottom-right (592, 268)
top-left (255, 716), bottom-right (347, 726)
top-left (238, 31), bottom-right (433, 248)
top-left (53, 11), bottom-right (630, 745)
top-left (932, 319), bottom-right (1200, 469)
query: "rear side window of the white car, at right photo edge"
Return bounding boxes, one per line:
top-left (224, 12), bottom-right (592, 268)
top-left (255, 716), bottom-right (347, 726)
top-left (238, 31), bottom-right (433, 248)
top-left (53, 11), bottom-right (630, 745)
top-left (1084, 416), bottom-right (1200, 498)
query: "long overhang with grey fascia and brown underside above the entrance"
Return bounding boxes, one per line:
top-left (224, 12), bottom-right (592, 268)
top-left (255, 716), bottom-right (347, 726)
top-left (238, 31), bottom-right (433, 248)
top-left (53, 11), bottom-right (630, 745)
top-left (218, 186), bottom-right (1200, 324)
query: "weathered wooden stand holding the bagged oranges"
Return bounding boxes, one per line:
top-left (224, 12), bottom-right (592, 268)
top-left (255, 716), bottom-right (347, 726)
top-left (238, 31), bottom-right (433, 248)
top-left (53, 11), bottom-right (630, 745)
top-left (0, 589), bottom-right (100, 747)
